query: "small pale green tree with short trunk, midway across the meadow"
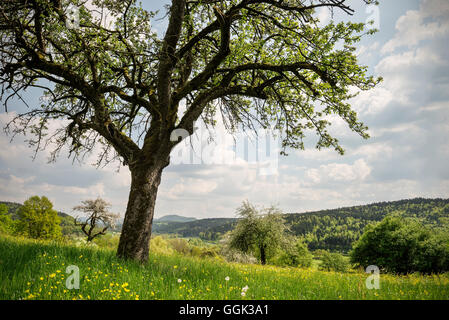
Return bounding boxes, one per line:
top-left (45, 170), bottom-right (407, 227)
top-left (229, 201), bottom-right (287, 264)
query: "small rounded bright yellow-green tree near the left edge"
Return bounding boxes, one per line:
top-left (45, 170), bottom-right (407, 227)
top-left (17, 196), bottom-right (62, 239)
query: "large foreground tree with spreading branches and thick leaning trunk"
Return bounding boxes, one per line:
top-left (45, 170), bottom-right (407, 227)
top-left (0, 0), bottom-right (380, 261)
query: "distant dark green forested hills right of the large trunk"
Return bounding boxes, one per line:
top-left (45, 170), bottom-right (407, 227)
top-left (154, 198), bottom-right (449, 252)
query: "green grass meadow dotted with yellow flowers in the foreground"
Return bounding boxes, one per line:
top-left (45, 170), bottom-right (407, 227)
top-left (0, 236), bottom-right (449, 300)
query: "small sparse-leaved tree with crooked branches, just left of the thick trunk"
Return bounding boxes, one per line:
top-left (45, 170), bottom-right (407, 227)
top-left (73, 198), bottom-right (119, 242)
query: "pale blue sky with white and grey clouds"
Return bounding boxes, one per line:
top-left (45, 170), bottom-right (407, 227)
top-left (0, 0), bottom-right (449, 218)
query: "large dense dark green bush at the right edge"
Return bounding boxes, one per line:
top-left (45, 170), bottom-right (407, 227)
top-left (351, 216), bottom-right (449, 274)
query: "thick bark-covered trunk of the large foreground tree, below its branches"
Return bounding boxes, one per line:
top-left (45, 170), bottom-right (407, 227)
top-left (117, 162), bottom-right (168, 263)
